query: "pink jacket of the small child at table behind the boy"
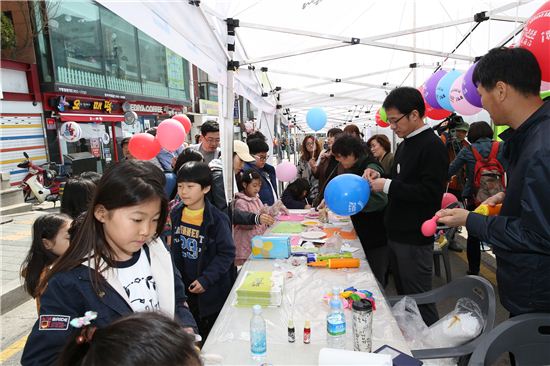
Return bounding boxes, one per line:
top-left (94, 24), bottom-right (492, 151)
top-left (233, 192), bottom-right (267, 266)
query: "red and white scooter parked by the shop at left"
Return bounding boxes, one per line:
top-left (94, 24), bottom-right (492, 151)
top-left (17, 152), bottom-right (66, 204)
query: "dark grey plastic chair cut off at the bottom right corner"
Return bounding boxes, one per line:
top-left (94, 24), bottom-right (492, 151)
top-left (468, 313), bottom-right (550, 366)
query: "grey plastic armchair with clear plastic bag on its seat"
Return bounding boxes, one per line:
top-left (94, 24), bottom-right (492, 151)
top-left (388, 276), bottom-right (496, 359)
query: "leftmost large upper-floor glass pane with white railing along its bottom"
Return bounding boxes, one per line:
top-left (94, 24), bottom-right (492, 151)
top-left (48, 0), bottom-right (105, 88)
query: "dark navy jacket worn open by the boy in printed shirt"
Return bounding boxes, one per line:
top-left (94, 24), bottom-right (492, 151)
top-left (170, 200), bottom-right (235, 317)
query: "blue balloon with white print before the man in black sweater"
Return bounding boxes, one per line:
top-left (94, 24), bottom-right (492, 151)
top-left (325, 174), bottom-right (370, 216)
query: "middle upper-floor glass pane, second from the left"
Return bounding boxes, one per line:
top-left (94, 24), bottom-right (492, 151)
top-left (101, 8), bottom-right (140, 81)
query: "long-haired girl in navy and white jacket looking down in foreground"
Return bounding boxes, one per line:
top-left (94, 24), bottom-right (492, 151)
top-left (21, 160), bottom-right (196, 365)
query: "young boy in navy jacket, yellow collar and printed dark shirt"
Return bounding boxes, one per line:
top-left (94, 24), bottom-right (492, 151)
top-left (170, 161), bottom-right (235, 341)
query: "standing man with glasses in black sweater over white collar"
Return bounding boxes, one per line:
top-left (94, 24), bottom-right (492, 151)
top-left (365, 87), bottom-right (449, 326)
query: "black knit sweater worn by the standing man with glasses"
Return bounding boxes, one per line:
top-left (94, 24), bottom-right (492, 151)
top-left (385, 129), bottom-right (449, 245)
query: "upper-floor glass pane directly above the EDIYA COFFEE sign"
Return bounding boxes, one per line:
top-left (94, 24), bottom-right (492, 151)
top-left (138, 31), bottom-right (168, 97)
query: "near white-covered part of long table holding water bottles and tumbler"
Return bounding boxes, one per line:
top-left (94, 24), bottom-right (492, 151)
top-left (202, 213), bottom-right (411, 365)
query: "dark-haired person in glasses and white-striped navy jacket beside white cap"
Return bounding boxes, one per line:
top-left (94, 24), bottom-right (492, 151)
top-left (243, 138), bottom-right (278, 206)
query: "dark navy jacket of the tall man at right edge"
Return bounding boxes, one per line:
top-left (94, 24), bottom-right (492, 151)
top-left (466, 101), bottom-right (550, 315)
